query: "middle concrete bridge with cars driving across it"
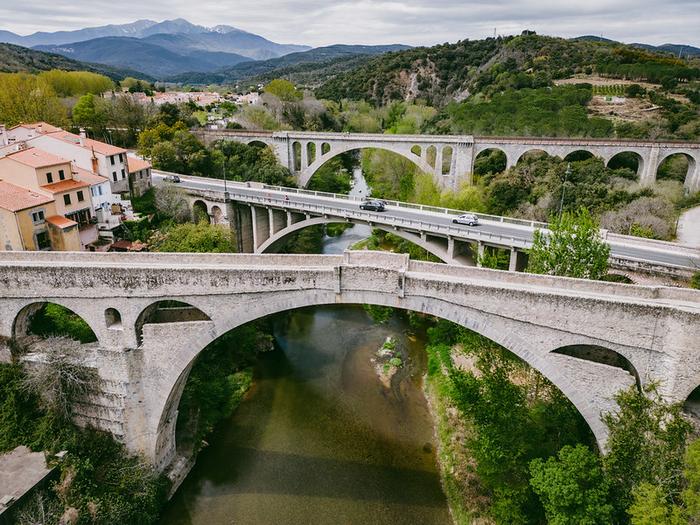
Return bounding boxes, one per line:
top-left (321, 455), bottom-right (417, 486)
top-left (153, 170), bottom-right (700, 277)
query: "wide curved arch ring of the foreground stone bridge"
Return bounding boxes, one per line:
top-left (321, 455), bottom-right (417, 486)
top-left (144, 290), bottom-right (607, 468)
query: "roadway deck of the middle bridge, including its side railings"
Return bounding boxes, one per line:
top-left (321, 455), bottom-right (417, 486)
top-left (153, 170), bottom-right (700, 275)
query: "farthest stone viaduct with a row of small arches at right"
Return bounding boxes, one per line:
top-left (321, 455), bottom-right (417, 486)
top-left (194, 130), bottom-right (700, 192)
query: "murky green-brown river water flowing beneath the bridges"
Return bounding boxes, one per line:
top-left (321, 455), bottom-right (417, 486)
top-left (162, 170), bottom-right (451, 525)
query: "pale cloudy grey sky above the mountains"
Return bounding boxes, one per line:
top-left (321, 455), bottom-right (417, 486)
top-left (0, 0), bottom-right (700, 47)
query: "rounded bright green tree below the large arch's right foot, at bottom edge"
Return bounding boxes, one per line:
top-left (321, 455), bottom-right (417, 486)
top-left (530, 445), bottom-right (613, 525)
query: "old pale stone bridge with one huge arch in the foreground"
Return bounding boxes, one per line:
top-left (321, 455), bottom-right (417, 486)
top-left (0, 252), bottom-right (700, 486)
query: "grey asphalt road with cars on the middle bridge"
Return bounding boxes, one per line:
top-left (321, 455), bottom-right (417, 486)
top-left (153, 170), bottom-right (700, 270)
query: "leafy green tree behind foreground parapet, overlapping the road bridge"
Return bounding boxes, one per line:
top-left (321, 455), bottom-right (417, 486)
top-left (528, 208), bottom-right (610, 279)
